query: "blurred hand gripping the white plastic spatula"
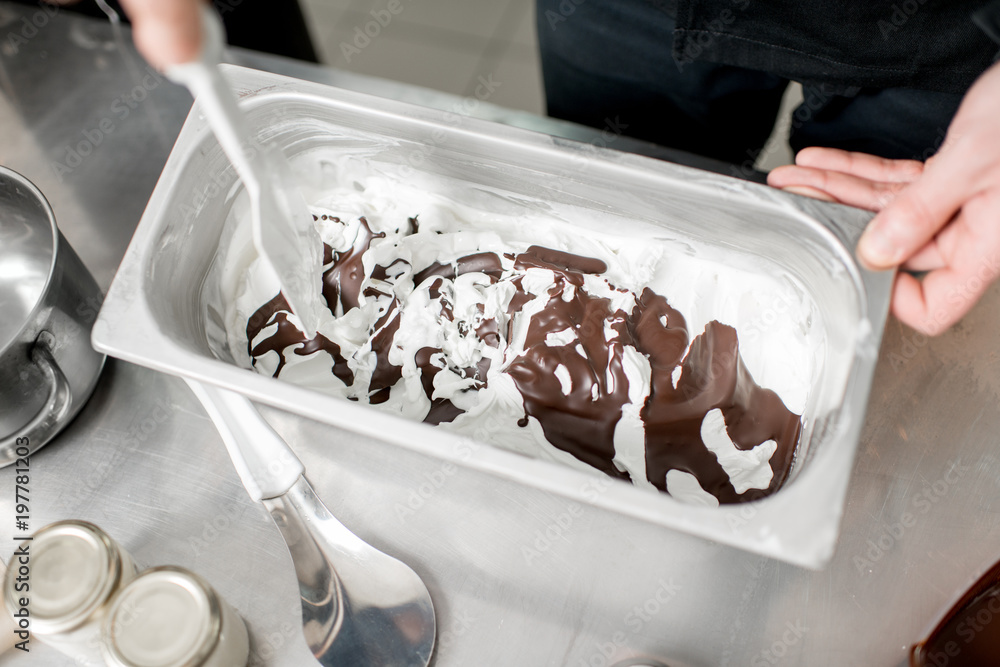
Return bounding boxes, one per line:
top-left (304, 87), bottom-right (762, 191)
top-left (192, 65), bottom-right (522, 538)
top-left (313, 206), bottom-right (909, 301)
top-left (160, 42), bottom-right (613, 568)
top-left (50, 0), bottom-right (205, 71)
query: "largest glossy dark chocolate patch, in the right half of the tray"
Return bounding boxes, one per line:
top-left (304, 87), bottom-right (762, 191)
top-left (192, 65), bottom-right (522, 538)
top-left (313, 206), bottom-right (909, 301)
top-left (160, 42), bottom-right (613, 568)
top-left (507, 274), bottom-right (801, 503)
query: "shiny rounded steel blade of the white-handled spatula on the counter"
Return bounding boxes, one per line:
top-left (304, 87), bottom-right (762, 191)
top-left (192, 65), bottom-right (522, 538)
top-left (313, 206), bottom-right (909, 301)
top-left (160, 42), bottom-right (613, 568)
top-left (263, 477), bottom-right (435, 667)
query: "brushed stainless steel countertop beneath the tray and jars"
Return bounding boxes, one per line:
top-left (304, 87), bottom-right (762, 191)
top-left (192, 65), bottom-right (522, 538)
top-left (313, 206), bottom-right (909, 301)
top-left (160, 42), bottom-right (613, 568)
top-left (0, 3), bottom-right (1000, 667)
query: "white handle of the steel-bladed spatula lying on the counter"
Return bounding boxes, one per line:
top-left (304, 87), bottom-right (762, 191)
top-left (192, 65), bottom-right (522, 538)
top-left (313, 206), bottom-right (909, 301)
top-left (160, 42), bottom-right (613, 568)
top-left (187, 379), bottom-right (305, 502)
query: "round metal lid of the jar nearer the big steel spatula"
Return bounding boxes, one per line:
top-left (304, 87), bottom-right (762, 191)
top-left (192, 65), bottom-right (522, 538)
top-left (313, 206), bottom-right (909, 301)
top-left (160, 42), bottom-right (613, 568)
top-left (104, 566), bottom-right (222, 667)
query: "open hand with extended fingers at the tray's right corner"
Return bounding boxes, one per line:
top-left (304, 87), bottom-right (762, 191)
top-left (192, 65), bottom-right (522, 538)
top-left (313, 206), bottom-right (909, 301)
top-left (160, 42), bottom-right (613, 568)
top-left (767, 64), bottom-right (1000, 335)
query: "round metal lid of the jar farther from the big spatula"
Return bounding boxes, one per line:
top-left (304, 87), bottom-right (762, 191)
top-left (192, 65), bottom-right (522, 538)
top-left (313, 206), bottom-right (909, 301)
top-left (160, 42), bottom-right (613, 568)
top-left (4, 520), bottom-right (123, 635)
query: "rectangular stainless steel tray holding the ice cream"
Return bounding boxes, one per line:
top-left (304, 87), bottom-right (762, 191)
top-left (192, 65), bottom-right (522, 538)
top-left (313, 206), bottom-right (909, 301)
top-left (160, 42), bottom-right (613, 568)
top-left (93, 67), bottom-right (892, 568)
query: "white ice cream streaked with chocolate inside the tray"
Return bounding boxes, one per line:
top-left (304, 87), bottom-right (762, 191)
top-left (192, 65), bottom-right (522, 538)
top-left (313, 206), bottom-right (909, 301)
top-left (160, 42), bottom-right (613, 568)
top-left (224, 154), bottom-right (824, 504)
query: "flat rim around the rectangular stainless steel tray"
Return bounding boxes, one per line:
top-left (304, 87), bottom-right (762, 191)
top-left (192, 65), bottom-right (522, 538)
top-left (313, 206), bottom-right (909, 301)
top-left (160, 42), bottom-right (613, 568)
top-left (92, 66), bottom-right (894, 569)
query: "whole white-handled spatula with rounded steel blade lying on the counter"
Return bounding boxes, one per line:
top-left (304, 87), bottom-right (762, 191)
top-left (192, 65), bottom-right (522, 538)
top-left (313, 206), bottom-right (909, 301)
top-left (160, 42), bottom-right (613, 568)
top-left (188, 380), bottom-right (435, 667)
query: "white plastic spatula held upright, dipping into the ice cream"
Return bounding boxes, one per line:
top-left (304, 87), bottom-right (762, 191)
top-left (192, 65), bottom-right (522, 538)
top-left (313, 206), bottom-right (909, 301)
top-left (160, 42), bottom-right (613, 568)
top-left (166, 5), bottom-right (324, 337)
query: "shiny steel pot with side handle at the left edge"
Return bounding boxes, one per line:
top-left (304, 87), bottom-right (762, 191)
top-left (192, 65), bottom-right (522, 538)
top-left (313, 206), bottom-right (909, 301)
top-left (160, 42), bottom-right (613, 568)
top-left (0, 167), bottom-right (105, 467)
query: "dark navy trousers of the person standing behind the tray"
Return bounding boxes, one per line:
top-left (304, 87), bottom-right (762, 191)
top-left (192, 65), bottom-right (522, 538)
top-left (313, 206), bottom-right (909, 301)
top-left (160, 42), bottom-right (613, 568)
top-left (537, 0), bottom-right (962, 168)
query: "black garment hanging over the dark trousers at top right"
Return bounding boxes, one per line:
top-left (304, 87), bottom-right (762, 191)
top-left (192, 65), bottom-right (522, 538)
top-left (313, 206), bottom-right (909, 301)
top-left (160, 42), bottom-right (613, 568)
top-left (673, 0), bottom-right (997, 94)
